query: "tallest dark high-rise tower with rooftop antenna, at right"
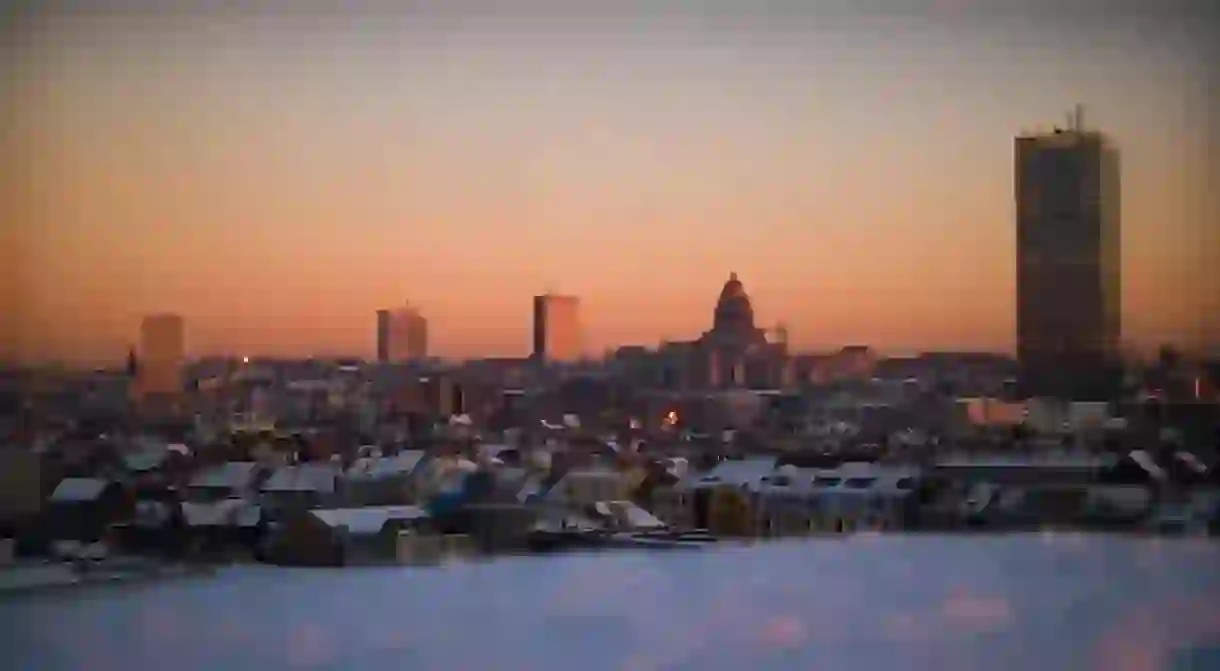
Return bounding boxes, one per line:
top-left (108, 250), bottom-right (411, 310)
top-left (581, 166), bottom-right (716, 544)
top-left (1015, 107), bottom-right (1121, 398)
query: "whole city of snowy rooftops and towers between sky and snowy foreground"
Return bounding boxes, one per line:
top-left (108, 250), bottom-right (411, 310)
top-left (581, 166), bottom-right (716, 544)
top-left (0, 106), bottom-right (1220, 583)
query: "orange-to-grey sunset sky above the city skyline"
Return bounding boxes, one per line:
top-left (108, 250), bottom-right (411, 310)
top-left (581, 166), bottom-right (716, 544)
top-left (0, 0), bottom-right (1220, 362)
